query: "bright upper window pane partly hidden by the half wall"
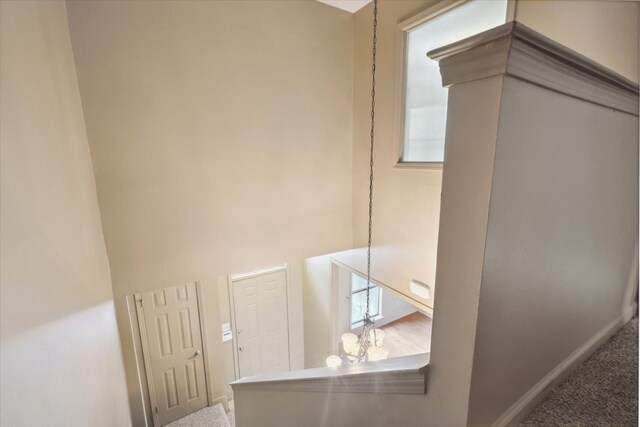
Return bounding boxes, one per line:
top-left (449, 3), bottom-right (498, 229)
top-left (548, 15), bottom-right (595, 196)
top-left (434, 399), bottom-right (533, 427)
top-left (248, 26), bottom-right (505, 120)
top-left (400, 0), bottom-right (507, 163)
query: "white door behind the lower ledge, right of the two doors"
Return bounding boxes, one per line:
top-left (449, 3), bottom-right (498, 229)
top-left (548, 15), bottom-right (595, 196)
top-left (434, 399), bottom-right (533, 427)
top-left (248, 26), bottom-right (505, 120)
top-left (232, 270), bottom-right (289, 377)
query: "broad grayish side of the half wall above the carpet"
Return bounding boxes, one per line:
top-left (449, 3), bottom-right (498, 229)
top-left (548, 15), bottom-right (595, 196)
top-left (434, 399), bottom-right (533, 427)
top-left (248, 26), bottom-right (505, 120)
top-left (469, 77), bottom-right (638, 425)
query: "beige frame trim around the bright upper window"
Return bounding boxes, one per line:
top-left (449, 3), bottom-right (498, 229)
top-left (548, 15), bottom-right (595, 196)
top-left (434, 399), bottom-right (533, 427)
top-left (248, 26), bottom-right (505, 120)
top-left (395, 0), bottom-right (516, 170)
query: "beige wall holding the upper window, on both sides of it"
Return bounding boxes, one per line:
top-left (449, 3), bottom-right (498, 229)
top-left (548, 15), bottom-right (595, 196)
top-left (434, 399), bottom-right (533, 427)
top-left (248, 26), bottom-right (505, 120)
top-left (344, 0), bottom-right (640, 314)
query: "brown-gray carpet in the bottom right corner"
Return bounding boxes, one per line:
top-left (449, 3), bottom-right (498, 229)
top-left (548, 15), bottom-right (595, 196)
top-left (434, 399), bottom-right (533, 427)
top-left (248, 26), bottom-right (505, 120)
top-left (521, 318), bottom-right (638, 427)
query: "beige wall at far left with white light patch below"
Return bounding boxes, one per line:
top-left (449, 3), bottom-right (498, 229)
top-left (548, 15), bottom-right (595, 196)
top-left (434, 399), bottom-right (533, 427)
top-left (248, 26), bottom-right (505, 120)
top-left (0, 1), bottom-right (130, 426)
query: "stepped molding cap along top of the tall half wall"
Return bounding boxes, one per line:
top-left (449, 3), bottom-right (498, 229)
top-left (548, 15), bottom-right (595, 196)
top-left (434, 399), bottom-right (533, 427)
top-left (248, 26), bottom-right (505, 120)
top-left (427, 22), bottom-right (638, 116)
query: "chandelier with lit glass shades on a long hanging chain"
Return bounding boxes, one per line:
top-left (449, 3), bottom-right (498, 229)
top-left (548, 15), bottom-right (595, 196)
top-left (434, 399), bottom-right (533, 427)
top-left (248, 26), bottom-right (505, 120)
top-left (326, 0), bottom-right (389, 367)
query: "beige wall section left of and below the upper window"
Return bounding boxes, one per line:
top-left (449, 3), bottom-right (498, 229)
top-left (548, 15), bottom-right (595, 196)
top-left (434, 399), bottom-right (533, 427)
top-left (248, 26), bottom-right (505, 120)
top-left (344, 1), bottom-right (442, 307)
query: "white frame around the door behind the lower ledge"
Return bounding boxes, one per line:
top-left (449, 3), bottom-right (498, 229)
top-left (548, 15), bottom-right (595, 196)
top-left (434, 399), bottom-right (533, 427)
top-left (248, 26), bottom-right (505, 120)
top-left (227, 263), bottom-right (292, 380)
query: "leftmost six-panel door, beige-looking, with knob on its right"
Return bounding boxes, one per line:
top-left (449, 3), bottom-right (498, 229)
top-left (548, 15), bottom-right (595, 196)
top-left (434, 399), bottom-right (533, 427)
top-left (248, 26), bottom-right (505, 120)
top-left (136, 283), bottom-right (207, 425)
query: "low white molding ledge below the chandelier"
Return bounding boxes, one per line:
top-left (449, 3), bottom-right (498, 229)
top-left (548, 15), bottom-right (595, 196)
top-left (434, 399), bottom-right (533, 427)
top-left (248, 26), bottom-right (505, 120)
top-left (231, 353), bottom-right (429, 394)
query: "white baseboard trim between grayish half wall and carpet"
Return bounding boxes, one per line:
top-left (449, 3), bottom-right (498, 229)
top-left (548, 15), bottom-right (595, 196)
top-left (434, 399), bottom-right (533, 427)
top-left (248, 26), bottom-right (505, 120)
top-left (492, 302), bottom-right (637, 427)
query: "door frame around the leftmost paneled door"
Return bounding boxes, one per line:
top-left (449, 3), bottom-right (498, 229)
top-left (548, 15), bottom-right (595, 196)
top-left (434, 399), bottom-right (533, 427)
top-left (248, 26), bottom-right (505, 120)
top-left (133, 282), bottom-right (211, 427)
